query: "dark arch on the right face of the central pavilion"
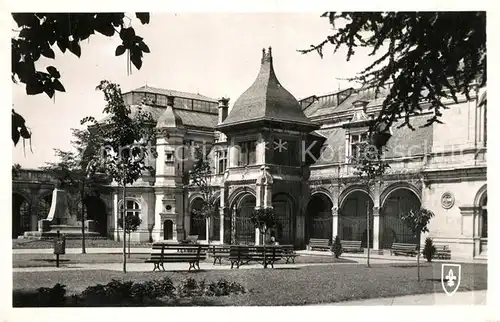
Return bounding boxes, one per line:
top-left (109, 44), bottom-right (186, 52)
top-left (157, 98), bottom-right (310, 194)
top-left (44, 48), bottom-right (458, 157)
top-left (270, 192), bottom-right (298, 245)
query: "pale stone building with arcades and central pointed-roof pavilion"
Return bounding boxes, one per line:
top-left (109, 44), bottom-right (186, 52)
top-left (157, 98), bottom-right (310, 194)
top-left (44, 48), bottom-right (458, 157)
top-left (14, 49), bottom-right (487, 258)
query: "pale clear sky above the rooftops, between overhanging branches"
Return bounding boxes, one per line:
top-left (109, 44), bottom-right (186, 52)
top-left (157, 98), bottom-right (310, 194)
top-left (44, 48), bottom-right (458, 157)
top-left (12, 13), bottom-right (378, 168)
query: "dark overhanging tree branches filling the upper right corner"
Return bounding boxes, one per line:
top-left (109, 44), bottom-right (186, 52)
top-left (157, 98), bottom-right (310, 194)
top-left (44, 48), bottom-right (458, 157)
top-left (299, 11), bottom-right (487, 129)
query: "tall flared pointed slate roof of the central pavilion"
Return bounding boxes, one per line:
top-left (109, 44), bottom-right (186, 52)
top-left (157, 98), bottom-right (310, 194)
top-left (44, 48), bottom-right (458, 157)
top-left (218, 48), bottom-right (318, 130)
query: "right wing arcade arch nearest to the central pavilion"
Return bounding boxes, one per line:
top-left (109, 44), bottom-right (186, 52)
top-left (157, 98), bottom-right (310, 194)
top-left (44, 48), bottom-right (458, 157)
top-left (305, 189), bottom-right (334, 241)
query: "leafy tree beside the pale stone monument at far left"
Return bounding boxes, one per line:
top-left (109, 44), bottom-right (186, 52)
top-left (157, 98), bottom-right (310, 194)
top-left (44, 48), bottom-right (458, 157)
top-left (41, 129), bottom-right (108, 254)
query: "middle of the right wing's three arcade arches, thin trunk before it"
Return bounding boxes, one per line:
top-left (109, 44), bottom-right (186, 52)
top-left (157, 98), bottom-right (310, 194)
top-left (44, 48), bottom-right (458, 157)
top-left (338, 185), bottom-right (374, 248)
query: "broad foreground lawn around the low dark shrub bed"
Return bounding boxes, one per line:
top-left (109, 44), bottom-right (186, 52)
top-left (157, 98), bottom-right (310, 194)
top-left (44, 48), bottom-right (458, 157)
top-left (13, 263), bottom-right (487, 306)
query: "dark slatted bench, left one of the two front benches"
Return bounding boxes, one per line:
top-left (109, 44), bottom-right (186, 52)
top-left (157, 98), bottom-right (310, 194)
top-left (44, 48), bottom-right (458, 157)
top-left (145, 243), bottom-right (208, 272)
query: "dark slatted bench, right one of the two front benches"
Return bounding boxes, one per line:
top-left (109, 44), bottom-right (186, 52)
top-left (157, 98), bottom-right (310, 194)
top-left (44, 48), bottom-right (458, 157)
top-left (229, 245), bottom-right (283, 268)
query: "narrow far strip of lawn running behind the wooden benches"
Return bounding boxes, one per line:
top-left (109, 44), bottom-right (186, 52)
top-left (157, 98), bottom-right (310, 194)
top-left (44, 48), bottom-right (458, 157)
top-left (12, 254), bottom-right (355, 267)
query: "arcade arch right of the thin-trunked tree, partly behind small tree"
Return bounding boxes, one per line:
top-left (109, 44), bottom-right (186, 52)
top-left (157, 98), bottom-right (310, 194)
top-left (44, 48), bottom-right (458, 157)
top-left (379, 184), bottom-right (422, 248)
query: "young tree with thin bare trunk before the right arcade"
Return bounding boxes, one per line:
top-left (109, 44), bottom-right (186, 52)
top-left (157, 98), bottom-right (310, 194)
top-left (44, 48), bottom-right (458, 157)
top-left (351, 132), bottom-right (390, 267)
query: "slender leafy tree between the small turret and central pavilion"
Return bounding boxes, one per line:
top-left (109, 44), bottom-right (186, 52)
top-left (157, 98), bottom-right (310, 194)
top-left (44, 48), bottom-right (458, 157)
top-left (188, 146), bottom-right (219, 242)
